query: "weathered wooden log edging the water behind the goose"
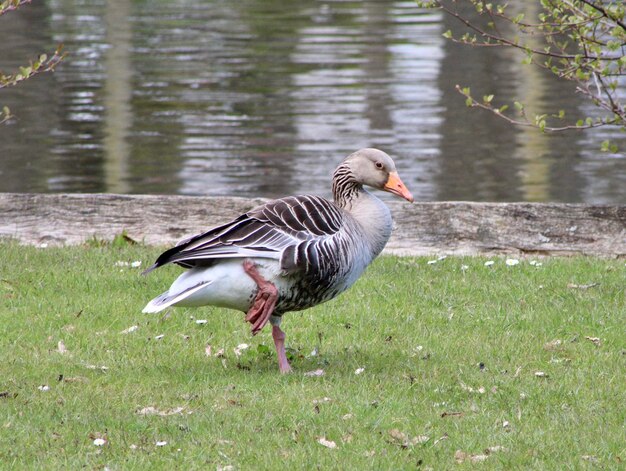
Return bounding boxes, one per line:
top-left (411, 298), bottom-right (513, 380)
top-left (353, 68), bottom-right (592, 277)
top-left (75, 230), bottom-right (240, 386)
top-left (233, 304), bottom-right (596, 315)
top-left (0, 193), bottom-right (626, 257)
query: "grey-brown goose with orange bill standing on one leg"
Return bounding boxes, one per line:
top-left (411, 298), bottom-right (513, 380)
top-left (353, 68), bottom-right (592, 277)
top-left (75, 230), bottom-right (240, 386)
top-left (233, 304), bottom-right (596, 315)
top-left (143, 148), bottom-right (413, 373)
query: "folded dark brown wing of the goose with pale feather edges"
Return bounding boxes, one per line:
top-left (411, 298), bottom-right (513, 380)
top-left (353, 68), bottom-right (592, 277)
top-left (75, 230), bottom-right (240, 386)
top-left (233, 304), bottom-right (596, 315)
top-left (144, 195), bottom-right (345, 273)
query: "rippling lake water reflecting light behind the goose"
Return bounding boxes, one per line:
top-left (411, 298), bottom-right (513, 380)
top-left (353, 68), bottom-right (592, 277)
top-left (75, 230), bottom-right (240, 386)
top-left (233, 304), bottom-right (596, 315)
top-left (0, 0), bottom-right (626, 203)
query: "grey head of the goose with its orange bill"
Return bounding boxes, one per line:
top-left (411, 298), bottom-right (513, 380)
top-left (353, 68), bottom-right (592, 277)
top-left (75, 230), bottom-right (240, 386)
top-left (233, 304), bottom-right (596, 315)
top-left (344, 148), bottom-right (413, 203)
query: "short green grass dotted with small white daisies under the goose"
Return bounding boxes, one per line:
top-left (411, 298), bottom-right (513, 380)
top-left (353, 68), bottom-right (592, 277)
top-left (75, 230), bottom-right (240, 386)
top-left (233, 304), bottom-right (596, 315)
top-left (0, 243), bottom-right (626, 470)
